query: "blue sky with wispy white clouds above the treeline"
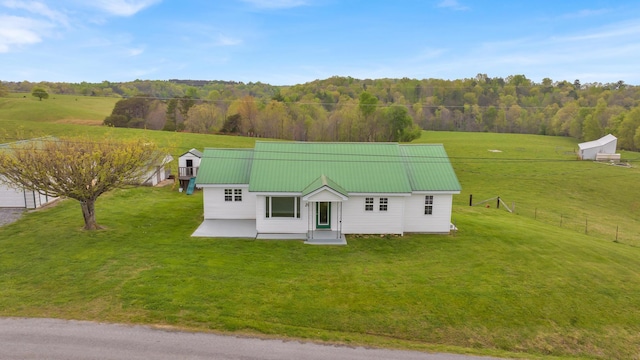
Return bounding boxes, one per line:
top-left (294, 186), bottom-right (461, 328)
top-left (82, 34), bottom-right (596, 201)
top-left (0, 0), bottom-right (640, 85)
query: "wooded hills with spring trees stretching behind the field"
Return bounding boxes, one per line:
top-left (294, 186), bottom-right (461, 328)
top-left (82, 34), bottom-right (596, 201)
top-left (2, 74), bottom-right (640, 151)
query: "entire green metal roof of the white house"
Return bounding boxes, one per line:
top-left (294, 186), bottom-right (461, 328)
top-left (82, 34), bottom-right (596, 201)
top-left (196, 141), bottom-right (460, 195)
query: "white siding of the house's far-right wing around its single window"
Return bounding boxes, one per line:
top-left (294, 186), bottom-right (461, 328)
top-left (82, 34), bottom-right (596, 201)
top-left (404, 194), bottom-right (453, 233)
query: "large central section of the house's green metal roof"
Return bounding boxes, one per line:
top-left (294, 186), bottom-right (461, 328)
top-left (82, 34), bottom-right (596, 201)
top-left (249, 142), bottom-right (411, 193)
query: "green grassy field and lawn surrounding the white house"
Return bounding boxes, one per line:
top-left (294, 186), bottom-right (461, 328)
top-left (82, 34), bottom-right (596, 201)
top-left (0, 94), bottom-right (640, 359)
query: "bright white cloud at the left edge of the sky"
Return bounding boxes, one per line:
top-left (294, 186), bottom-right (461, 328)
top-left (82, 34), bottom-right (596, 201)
top-left (0, 15), bottom-right (51, 53)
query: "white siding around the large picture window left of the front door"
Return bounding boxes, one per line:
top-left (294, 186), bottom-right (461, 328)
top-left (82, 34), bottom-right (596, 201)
top-left (253, 195), bottom-right (308, 234)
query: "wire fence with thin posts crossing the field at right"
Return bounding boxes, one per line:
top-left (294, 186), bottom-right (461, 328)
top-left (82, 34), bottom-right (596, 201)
top-left (469, 197), bottom-right (640, 247)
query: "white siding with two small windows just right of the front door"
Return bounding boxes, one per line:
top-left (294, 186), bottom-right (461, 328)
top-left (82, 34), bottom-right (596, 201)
top-left (342, 195), bottom-right (405, 234)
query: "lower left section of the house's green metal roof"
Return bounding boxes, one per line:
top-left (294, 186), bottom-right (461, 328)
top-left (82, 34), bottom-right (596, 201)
top-left (196, 149), bottom-right (253, 185)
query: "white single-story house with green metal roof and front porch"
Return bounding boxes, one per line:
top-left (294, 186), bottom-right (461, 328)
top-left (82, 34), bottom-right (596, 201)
top-left (193, 141), bottom-right (461, 243)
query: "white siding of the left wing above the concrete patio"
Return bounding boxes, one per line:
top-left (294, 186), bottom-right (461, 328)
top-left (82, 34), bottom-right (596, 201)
top-left (202, 185), bottom-right (256, 219)
